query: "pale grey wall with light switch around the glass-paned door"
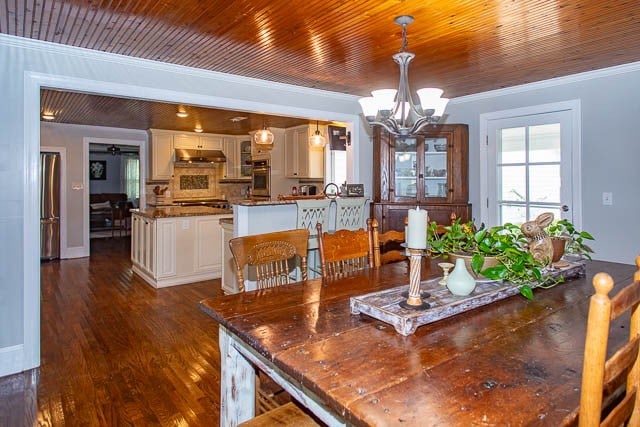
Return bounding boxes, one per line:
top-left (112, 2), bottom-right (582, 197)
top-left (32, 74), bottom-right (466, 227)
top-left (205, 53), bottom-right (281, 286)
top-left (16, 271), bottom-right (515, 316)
top-left (447, 63), bottom-right (640, 264)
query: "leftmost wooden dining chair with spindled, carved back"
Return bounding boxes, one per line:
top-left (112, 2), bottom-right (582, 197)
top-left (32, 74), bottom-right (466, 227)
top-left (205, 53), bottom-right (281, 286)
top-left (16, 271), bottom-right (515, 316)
top-left (229, 229), bottom-right (309, 292)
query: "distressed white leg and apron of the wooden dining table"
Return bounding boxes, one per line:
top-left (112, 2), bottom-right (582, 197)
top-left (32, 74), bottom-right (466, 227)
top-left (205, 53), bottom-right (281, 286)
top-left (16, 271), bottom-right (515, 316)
top-left (219, 325), bottom-right (346, 427)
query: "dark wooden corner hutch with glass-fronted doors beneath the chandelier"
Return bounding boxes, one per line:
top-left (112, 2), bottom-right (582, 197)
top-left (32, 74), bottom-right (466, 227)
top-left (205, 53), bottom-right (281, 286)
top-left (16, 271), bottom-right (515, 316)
top-left (371, 124), bottom-right (471, 232)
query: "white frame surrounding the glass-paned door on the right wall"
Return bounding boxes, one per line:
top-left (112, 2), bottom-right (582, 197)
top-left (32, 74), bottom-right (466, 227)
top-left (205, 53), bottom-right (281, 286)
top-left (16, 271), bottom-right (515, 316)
top-left (480, 99), bottom-right (582, 229)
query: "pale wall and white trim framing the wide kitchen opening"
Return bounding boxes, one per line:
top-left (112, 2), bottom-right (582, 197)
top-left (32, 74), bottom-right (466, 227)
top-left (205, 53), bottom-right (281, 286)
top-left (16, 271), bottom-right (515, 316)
top-left (0, 35), bottom-right (360, 375)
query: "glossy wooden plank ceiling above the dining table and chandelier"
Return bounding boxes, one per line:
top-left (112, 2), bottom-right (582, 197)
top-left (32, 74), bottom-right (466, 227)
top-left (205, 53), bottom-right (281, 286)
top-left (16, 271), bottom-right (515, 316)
top-left (5, 0), bottom-right (640, 131)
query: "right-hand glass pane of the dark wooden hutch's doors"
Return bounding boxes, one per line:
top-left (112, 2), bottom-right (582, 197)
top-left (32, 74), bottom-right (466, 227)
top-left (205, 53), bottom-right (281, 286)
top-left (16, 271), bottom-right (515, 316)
top-left (424, 138), bottom-right (449, 199)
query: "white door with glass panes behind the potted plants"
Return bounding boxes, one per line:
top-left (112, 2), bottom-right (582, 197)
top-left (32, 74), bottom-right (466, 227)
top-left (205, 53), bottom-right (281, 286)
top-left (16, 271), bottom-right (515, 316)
top-left (487, 107), bottom-right (573, 224)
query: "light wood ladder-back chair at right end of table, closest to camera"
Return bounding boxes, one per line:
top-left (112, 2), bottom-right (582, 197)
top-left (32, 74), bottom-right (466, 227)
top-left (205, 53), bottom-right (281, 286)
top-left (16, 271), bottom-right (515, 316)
top-left (562, 256), bottom-right (640, 427)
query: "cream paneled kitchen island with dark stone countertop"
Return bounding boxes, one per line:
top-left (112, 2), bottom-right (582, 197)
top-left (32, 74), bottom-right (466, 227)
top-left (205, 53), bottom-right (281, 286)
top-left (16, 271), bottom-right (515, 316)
top-left (131, 206), bottom-right (233, 288)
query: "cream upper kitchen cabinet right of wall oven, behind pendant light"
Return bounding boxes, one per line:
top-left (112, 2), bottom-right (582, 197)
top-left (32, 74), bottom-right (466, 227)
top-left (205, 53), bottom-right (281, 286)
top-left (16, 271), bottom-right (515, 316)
top-left (284, 125), bottom-right (326, 179)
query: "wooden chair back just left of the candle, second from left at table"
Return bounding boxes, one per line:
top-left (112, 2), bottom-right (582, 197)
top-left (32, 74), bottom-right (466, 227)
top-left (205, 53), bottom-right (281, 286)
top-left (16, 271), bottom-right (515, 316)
top-left (316, 223), bottom-right (374, 278)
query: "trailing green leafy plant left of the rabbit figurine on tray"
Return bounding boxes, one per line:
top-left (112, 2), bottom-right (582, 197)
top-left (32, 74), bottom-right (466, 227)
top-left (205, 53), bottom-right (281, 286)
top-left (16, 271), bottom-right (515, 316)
top-left (427, 219), bottom-right (558, 299)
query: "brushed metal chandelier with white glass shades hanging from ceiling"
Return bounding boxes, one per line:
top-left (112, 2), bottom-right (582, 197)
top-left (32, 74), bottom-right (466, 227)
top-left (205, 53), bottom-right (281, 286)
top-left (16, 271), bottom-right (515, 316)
top-left (358, 15), bottom-right (449, 136)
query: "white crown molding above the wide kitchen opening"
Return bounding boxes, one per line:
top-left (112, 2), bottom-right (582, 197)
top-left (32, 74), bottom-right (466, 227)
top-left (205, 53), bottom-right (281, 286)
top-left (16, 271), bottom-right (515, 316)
top-left (0, 34), bottom-right (360, 102)
